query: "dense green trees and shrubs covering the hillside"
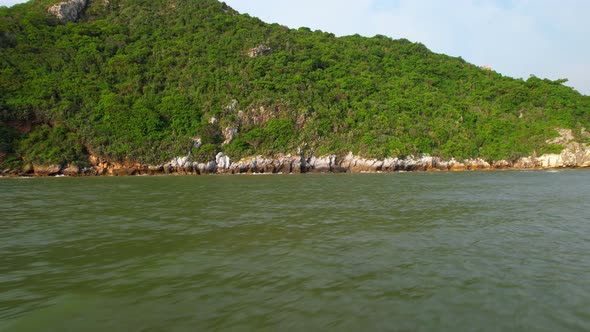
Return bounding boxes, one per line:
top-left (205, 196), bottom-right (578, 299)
top-left (0, 0), bottom-right (590, 168)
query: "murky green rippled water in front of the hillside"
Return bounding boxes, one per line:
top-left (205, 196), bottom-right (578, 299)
top-left (0, 170), bottom-right (590, 332)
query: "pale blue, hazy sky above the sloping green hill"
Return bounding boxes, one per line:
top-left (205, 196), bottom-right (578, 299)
top-left (0, 0), bottom-right (590, 95)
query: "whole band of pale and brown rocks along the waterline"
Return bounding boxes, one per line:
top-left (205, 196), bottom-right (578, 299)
top-left (0, 129), bottom-right (590, 176)
